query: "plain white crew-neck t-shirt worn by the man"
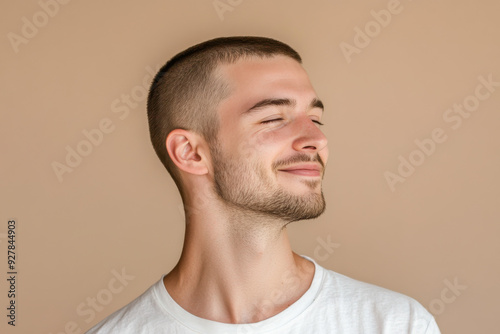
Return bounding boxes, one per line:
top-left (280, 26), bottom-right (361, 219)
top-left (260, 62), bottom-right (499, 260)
top-left (87, 256), bottom-right (440, 334)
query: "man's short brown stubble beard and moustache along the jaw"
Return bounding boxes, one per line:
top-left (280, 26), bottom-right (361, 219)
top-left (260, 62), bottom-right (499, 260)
top-left (210, 143), bottom-right (326, 225)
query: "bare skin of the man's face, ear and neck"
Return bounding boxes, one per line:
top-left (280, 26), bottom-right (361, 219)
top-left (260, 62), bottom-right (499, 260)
top-left (164, 56), bottom-right (328, 323)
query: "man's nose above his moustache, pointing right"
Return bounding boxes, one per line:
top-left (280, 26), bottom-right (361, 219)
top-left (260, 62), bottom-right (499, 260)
top-left (293, 117), bottom-right (328, 153)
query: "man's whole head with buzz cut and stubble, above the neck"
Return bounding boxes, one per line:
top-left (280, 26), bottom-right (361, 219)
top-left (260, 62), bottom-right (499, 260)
top-left (148, 37), bottom-right (327, 220)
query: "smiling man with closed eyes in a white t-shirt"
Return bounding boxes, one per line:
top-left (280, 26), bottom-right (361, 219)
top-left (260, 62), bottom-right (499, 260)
top-left (88, 37), bottom-right (439, 334)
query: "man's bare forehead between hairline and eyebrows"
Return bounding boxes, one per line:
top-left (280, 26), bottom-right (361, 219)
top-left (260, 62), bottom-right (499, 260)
top-left (217, 56), bottom-right (316, 111)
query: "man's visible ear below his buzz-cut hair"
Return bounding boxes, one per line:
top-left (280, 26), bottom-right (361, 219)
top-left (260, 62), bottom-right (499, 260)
top-left (165, 129), bottom-right (208, 175)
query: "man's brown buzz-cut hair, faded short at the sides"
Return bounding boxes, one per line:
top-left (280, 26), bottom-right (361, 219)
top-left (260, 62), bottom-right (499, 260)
top-left (147, 36), bottom-right (302, 194)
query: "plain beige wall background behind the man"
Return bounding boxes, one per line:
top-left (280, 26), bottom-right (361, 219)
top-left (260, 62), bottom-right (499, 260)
top-left (0, 0), bottom-right (500, 334)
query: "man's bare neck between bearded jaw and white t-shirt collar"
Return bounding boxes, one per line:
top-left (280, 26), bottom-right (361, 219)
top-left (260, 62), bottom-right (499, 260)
top-left (164, 198), bottom-right (314, 323)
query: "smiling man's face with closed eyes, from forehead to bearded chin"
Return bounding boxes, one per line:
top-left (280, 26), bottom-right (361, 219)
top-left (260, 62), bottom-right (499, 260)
top-left (211, 56), bottom-right (328, 221)
